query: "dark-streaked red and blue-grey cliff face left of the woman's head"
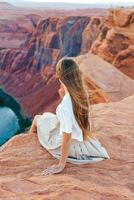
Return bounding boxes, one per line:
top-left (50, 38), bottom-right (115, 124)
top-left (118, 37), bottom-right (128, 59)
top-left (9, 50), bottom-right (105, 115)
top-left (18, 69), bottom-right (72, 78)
top-left (0, 16), bottom-right (104, 117)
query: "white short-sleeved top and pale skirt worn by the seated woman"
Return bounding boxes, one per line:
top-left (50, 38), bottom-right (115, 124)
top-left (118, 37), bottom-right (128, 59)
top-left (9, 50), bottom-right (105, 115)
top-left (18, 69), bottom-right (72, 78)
top-left (37, 93), bottom-right (110, 164)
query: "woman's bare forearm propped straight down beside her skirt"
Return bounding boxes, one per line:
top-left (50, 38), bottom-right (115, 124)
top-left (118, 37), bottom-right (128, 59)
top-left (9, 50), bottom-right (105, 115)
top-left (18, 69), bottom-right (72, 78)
top-left (59, 132), bottom-right (72, 168)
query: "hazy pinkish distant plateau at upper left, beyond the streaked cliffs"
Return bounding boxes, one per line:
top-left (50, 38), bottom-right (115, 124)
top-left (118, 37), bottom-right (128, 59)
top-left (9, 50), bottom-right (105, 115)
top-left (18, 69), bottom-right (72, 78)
top-left (0, 2), bottom-right (106, 48)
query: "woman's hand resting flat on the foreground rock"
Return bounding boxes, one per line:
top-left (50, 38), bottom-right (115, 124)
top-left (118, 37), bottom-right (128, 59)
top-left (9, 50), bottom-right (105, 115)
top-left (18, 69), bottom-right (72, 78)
top-left (41, 164), bottom-right (65, 176)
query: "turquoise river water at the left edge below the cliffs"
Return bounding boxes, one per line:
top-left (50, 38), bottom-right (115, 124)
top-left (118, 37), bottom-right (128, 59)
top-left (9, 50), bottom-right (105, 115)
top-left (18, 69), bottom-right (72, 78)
top-left (0, 107), bottom-right (20, 146)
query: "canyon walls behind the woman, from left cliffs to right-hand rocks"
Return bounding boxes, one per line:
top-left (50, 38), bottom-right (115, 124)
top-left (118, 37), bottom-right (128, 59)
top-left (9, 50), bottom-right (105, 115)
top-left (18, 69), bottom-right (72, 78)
top-left (0, 6), bottom-right (134, 118)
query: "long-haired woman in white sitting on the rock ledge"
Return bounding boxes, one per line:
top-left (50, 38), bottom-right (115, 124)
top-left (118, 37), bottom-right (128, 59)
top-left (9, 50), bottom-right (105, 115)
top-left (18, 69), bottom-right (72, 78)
top-left (30, 57), bottom-right (110, 175)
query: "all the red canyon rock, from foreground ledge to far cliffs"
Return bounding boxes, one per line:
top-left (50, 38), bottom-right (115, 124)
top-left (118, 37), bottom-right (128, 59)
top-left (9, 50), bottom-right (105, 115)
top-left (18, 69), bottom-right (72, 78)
top-left (0, 4), bottom-right (134, 200)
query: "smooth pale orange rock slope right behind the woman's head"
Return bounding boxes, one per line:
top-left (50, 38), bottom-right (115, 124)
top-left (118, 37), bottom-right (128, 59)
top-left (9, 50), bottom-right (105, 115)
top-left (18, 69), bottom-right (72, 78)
top-left (76, 53), bottom-right (134, 103)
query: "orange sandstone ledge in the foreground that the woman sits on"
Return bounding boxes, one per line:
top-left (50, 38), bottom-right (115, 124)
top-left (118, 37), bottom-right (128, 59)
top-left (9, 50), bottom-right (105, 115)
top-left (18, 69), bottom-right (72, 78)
top-left (0, 96), bottom-right (134, 200)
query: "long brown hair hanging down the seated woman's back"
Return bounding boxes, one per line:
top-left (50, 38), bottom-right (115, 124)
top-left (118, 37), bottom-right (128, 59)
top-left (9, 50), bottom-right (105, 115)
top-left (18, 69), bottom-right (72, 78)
top-left (56, 57), bottom-right (91, 140)
